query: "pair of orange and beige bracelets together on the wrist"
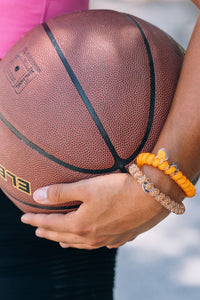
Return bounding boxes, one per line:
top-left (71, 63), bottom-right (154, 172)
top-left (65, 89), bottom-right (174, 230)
top-left (129, 149), bottom-right (196, 215)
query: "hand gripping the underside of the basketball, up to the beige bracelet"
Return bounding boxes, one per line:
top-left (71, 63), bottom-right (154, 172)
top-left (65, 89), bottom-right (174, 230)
top-left (22, 174), bottom-right (168, 249)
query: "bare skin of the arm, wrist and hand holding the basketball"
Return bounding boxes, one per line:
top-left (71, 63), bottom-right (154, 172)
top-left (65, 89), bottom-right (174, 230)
top-left (22, 11), bottom-right (200, 249)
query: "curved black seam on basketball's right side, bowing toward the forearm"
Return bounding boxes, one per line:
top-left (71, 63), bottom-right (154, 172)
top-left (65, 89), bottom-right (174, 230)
top-left (124, 14), bottom-right (156, 163)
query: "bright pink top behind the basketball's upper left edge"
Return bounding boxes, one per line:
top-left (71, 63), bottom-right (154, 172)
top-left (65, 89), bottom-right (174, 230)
top-left (0, 0), bottom-right (89, 58)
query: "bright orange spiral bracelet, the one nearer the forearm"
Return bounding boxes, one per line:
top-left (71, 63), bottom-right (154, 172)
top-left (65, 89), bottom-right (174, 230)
top-left (137, 149), bottom-right (196, 197)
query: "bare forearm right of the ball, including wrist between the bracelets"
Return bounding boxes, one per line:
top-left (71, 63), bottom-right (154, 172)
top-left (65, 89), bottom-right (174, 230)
top-left (144, 13), bottom-right (200, 199)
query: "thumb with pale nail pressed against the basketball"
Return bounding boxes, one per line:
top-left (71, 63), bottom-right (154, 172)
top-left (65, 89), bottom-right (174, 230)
top-left (33, 183), bottom-right (85, 204)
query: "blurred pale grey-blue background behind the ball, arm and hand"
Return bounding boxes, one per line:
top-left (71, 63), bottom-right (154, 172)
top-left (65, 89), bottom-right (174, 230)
top-left (90, 0), bottom-right (200, 300)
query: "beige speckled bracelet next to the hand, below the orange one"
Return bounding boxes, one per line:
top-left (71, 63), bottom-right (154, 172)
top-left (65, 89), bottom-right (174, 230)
top-left (129, 164), bottom-right (185, 215)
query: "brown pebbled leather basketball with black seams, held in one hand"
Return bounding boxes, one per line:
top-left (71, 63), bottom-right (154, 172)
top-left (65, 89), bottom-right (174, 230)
top-left (0, 10), bottom-right (183, 213)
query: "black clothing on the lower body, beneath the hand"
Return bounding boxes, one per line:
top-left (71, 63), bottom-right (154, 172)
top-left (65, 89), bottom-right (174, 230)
top-left (0, 190), bottom-right (116, 300)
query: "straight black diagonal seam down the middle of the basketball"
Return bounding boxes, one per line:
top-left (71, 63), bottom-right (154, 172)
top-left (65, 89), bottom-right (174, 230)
top-left (42, 23), bottom-right (121, 169)
